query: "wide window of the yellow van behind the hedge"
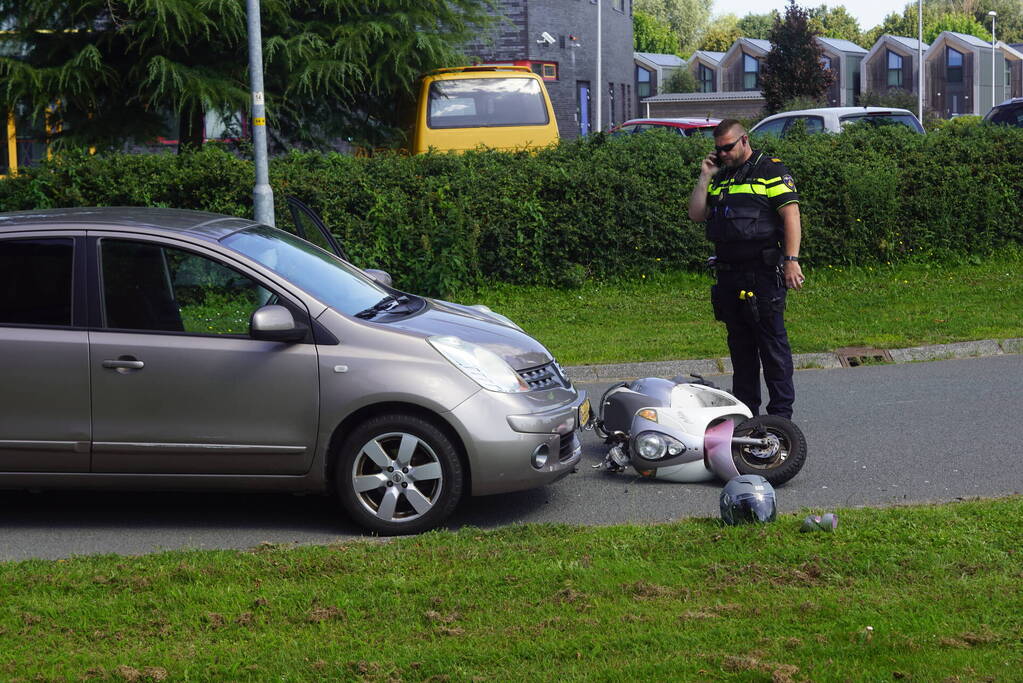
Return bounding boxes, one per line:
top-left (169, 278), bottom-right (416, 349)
top-left (427, 78), bottom-right (548, 128)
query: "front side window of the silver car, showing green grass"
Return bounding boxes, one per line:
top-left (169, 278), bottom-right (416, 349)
top-left (99, 239), bottom-right (275, 335)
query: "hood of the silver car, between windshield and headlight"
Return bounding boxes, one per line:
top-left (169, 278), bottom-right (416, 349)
top-left (387, 299), bottom-right (553, 370)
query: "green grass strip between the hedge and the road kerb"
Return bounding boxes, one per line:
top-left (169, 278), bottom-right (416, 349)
top-left (453, 252), bottom-right (1023, 365)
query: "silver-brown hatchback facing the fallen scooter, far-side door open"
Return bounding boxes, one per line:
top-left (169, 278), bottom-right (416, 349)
top-left (0, 209), bottom-right (589, 534)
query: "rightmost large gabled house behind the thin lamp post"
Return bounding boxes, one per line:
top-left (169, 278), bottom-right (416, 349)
top-left (924, 31), bottom-right (1023, 119)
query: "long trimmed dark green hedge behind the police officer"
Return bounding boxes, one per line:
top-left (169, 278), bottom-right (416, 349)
top-left (0, 122), bottom-right (1023, 294)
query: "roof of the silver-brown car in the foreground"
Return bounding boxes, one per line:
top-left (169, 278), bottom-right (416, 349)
top-left (0, 207), bottom-right (258, 241)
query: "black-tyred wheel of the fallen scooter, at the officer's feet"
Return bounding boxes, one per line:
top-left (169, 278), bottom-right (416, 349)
top-left (731, 415), bottom-right (806, 486)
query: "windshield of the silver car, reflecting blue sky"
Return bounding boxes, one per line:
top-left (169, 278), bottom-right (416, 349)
top-left (221, 225), bottom-right (390, 315)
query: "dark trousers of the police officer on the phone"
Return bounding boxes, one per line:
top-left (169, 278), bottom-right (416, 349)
top-left (711, 269), bottom-right (796, 418)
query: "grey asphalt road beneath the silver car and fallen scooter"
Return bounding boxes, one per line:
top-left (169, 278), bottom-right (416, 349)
top-left (0, 355), bottom-right (1023, 560)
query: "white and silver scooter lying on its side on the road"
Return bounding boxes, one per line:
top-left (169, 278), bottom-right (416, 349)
top-left (593, 375), bottom-right (806, 486)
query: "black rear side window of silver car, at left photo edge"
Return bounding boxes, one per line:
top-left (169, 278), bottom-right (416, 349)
top-left (0, 237), bottom-right (75, 326)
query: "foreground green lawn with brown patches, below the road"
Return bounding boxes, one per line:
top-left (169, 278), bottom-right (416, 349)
top-left (0, 497), bottom-right (1023, 681)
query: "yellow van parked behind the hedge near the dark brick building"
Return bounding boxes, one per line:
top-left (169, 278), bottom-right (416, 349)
top-left (409, 65), bottom-right (558, 154)
